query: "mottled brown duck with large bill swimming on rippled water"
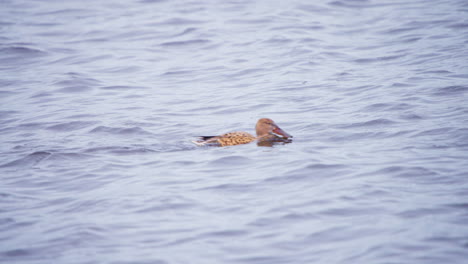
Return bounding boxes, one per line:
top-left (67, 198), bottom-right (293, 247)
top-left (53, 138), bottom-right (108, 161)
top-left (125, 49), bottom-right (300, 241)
top-left (192, 118), bottom-right (293, 147)
